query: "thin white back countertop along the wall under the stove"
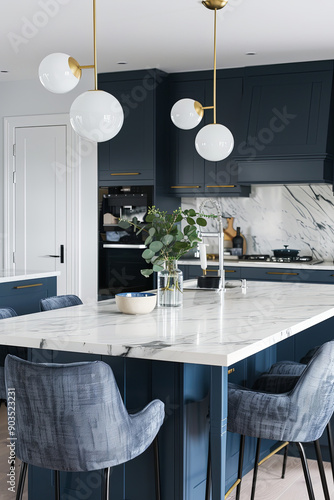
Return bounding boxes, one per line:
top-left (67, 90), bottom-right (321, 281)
top-left (178, 257), bottom-right (334, 271)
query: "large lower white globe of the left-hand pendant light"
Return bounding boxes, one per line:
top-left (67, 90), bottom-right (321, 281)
top-left (70, 90), bottom-right (124, 142)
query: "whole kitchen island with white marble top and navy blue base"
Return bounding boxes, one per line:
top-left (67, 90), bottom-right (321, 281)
top-left (0, 282), bottom-right (334, 500)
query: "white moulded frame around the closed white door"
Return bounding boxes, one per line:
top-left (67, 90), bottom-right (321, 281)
top-left (3, 113), bottom-right (81, 293)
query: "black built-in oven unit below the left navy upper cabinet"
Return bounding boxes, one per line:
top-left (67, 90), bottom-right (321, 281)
top-left (98, 186), bottom-right (153, 300)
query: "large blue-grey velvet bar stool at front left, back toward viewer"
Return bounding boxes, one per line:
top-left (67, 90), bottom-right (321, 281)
top-left (5, 355), bottom-right (165, 500)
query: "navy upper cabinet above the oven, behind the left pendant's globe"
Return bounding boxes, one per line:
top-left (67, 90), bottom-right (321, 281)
top-left (98, 70), bottom-right (168, 185)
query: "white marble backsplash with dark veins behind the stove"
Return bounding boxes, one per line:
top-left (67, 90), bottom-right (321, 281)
top-left (182, 184), bottom-right (334, 261)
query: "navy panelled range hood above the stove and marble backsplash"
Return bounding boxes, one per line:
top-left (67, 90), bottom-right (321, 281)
top-left (236, 61), bottom-right (333, 184)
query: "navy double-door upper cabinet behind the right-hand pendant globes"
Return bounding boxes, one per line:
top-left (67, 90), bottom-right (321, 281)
top-left (170, 69), bottom-right (249, 196)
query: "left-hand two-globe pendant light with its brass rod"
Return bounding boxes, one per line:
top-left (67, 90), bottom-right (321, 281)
top-left (39, 0), bottom-right (124, 142)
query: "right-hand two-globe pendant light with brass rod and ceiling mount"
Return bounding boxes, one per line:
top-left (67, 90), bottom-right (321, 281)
top-left (171, 0), bottom-right (234, 161)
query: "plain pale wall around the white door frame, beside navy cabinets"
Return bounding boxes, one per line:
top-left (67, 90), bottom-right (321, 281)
top-left (0, 71), bottom-right (97, 302)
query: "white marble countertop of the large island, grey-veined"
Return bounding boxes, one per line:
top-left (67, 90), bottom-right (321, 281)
top-left (0, 282), bottom-right (334, 366)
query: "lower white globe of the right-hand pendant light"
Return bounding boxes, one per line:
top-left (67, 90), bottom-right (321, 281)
top-left (195, 123), bottom-right (234, 161)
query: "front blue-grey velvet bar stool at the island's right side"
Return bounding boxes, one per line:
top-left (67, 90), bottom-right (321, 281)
top-left (227, 342), bottom-right (334, 500)
